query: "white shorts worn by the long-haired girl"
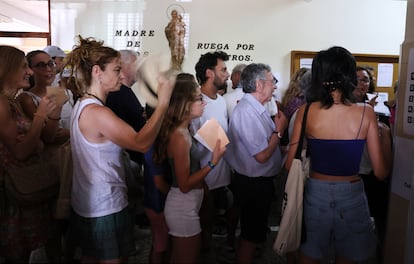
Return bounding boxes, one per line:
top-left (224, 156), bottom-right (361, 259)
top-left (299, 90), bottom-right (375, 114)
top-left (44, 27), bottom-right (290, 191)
top-left (164, 187), bottom-right (204, 237)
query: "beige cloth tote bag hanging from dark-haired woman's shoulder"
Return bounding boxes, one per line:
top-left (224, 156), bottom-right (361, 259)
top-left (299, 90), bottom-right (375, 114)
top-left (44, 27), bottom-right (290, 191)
top-left (273, 104), bottom-right (310, 256)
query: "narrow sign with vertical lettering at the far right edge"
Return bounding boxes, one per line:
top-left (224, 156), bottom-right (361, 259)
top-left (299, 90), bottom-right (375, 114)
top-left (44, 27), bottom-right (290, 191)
top-left (403, 48), bottom-right (414, 135)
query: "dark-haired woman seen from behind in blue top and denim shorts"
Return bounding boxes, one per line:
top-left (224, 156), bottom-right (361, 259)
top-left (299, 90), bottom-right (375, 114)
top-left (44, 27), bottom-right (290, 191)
top-left (285, 47), bottom-right (392, 263)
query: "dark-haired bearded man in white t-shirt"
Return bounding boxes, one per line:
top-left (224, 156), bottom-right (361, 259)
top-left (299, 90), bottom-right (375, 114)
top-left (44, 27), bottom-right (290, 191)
top-left (190, 51), bottom-right (232, 263)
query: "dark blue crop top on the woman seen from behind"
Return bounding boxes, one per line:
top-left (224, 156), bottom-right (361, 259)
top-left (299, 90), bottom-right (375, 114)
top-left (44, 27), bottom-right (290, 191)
top-left (307, 104), bottom-right (366, 176)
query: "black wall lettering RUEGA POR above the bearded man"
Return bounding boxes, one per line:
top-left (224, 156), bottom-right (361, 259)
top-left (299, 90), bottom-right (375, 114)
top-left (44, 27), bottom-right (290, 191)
top-left (196, 42), bottom-right (254, 62)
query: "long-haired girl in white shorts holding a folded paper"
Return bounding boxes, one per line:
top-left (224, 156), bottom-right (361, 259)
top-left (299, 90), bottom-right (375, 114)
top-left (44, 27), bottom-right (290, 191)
top-left (154, 73), bottom-right (225, 263)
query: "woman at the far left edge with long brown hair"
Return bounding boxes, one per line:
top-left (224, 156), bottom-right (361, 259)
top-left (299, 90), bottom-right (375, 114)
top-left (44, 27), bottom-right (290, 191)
top-left (0, 46), bottom-right (59, 263)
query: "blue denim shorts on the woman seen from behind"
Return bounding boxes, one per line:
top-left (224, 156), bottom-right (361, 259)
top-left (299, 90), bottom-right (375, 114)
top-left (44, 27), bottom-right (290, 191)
top-left (301, 178), bottom-right (377, 261)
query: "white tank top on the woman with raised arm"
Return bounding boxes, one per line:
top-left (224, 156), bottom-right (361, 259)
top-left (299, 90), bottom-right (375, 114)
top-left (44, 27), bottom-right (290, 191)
top-left (70, 98), bottom-right (128, 217)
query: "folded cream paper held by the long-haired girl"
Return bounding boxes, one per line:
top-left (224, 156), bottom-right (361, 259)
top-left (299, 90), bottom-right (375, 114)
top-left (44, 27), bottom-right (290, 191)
top-left (194, 118), bottom-right (230, 152)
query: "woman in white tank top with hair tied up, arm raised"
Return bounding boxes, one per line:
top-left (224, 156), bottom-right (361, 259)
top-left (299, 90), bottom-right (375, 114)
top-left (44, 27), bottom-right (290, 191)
top-left (66, 37), bottom-right (172, 263)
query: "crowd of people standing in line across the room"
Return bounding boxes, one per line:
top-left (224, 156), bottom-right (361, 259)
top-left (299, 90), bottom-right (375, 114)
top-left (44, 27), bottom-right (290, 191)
top-left (0, 36), bottom-right (392, 263)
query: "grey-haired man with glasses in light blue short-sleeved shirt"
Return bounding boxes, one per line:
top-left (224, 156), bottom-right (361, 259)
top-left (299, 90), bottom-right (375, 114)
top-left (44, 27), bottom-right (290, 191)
top-left (225, 63), bottom-right (288, 263)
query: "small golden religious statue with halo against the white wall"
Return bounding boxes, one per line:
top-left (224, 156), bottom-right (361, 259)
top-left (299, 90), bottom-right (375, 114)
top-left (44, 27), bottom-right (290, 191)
top-left (165, 10), bottom-right (185, 71)
